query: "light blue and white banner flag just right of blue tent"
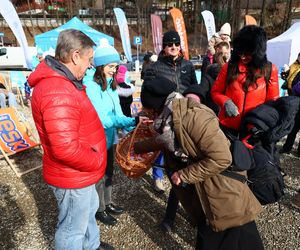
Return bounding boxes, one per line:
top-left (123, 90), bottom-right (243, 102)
top-left (114, 8), bottom-right (132, 62)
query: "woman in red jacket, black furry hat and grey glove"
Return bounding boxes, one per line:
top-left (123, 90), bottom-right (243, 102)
top-left (211, 25), bottom-right (279, 135)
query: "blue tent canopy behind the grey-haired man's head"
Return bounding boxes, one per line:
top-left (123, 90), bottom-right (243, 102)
top-left (34, 17), bottom-right (114, 51)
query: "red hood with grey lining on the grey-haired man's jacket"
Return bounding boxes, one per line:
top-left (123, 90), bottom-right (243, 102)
top-left (28, 56), bottom-right (83, 90)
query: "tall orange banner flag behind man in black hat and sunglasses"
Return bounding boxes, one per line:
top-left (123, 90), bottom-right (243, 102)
top-left (170, 8), bottom-right (189, 60)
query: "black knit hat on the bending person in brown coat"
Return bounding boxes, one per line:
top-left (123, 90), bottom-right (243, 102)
top-left (141, 77), bottom-right (177, 110)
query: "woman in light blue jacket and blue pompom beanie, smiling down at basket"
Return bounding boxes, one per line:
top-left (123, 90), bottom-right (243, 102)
top-left (83, 39), bottom-right (139, 225)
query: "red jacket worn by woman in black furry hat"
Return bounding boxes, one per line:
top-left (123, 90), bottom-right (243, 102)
top-left (211, 63), bottom-right (279, 130)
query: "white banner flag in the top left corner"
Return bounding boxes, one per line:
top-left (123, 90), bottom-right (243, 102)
top-left (0, 0), bottom-right (32, 69)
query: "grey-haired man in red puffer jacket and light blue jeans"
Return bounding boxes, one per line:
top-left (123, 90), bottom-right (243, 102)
top-left (28, 29), bottom-right (110, 249)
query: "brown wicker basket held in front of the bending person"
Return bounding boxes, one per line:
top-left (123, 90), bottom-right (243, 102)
top-left (115, 123), bottom-right (159, 179)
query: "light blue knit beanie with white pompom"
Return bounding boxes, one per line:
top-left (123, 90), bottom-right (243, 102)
top-left (94, 38), bottom-right (120, 67)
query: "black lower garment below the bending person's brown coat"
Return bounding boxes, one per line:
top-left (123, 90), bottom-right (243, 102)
top-left (196, 221), bottom-right (264, 250)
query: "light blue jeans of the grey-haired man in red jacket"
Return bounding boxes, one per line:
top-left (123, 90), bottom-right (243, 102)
top-left (49, 185), bottom-right (100, 250)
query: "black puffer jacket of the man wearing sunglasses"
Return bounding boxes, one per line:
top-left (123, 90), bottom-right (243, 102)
top-left (144, 51), bottom-right (198, 93)
